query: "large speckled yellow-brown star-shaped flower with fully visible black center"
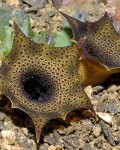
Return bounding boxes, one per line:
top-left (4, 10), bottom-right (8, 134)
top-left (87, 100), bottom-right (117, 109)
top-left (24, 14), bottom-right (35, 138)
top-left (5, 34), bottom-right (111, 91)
top-left (0, 22), bottom-right (95, 142)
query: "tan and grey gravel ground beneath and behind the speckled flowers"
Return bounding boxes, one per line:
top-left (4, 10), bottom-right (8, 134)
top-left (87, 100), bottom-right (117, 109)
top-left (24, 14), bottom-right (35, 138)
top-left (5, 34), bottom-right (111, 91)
top-left (0, 0), bottom-right (120, 150)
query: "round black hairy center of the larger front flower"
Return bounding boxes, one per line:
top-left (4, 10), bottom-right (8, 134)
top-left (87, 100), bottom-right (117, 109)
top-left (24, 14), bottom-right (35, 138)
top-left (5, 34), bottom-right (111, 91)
top-left (20, 71), bottom-right (54, 102)
